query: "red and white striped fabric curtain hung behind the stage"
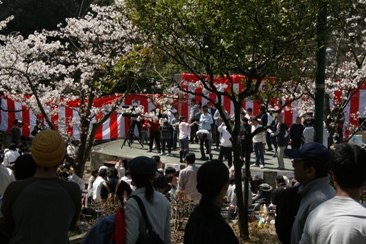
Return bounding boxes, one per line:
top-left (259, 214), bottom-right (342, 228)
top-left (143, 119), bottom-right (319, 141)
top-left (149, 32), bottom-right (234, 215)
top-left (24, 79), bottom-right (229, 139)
top-left (0, 73), bottom-right (366, 140)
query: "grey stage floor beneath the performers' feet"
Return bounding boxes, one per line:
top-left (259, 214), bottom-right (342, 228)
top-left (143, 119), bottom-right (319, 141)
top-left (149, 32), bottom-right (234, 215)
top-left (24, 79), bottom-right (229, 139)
top-left (91, 139), bottom-right (293, 185)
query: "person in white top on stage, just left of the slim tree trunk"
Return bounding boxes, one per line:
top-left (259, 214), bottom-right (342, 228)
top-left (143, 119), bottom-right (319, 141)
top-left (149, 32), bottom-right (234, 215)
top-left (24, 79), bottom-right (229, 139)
top-left (217, 120), bottom-right (234, 168)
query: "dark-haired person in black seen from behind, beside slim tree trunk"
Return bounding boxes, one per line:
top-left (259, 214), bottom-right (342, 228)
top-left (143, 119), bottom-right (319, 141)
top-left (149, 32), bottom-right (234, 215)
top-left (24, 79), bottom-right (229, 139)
top-left (184, 160), bottom-right (239, 244)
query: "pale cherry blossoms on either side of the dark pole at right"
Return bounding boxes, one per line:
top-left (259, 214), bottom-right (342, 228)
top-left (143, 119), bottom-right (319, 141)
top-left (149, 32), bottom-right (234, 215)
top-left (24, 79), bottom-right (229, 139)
top-left (270, 1), bottom-right (366, 145)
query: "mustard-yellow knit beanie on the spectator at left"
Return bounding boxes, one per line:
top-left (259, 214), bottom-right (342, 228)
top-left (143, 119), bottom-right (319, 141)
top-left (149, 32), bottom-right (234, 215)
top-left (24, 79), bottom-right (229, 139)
top-left (31, 130), bottom-right (66, 167)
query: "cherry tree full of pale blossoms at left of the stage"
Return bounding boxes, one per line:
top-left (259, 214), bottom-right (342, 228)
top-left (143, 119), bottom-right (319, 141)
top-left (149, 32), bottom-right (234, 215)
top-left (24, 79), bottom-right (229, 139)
top-left (0, 1), bottom-right (149, 176)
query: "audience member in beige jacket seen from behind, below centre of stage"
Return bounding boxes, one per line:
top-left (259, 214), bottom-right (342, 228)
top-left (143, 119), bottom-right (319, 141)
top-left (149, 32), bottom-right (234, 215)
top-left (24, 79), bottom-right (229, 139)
top-left (178, 153), bottom-right (201, 201)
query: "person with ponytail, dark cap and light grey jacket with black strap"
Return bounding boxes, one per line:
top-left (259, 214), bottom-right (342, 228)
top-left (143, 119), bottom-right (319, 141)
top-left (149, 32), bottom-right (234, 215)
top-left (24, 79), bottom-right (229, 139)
top-left (125, 156), bottom-right (170, 244)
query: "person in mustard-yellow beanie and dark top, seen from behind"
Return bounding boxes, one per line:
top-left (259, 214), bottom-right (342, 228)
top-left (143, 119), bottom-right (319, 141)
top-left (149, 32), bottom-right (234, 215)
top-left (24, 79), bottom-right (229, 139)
top-left (0, 130), bottom-right (81, 244)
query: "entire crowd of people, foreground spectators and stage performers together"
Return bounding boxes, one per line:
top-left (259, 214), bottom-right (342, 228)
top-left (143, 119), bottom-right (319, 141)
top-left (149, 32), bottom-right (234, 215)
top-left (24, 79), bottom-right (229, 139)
top-left (0, 99), bottom-right (366, 244)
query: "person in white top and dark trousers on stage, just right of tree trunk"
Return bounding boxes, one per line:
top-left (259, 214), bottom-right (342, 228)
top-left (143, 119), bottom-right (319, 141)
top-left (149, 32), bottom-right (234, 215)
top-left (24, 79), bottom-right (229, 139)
top-left (250, 116), bottom-right (266, 169)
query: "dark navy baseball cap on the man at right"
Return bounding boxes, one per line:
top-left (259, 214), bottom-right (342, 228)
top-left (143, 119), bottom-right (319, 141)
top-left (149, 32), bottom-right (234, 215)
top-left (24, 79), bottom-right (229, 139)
top-left (285, 142), bottom-right (329, 171)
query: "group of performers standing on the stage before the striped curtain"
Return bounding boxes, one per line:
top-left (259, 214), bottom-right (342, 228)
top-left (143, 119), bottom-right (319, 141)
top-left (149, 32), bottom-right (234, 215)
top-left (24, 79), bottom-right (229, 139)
top-left (123, 99), bottom-right (343, 170)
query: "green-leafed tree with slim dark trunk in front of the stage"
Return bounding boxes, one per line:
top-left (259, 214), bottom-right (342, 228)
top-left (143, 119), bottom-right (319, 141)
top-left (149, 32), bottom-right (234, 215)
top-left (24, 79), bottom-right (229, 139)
top-left (128, 0), bottom-right (332, 239)
